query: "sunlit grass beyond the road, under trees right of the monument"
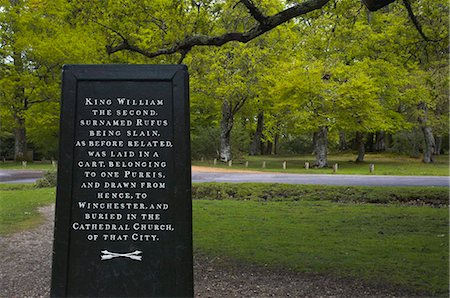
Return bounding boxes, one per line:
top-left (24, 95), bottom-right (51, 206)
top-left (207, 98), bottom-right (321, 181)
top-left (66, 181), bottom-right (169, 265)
top-left (193, 153), bottom-right (449, 176)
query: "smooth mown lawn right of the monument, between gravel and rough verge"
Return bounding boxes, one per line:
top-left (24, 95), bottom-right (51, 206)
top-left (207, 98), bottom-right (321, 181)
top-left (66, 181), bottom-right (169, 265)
top-left (193, 200), bottom-right (449, 295)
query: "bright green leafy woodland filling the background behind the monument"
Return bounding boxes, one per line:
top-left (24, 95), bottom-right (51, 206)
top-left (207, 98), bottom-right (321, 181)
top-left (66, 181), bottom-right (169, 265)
top-left (0, 0), bottom-right (449, 167)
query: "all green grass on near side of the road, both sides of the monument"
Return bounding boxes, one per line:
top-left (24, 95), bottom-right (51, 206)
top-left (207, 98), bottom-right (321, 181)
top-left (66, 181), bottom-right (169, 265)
top-left (0, 184), bottom-right (449, 296)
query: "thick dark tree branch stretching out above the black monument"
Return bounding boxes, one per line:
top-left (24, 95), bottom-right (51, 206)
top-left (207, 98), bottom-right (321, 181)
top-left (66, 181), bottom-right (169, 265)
top-left (106, 0), bottom-right (330, 58)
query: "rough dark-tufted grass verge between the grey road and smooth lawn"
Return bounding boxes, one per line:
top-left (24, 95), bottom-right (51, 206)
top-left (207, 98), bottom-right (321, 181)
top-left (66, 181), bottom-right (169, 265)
top-left (192, 183), bottom-right (449, 207)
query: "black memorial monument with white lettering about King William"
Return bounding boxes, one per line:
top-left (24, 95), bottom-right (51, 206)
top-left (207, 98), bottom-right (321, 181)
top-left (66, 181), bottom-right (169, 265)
top-left (51, 65), bottom-right (193, 297)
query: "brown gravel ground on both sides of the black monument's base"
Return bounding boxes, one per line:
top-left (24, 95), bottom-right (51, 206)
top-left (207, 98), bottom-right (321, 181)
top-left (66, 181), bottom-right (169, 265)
top-left (0, 206), bottom-right (424, 298)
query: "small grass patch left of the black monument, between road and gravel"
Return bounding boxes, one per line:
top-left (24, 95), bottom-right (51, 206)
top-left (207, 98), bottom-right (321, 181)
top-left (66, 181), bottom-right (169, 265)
top-left (0, 184), bottom-right (55, 235)
